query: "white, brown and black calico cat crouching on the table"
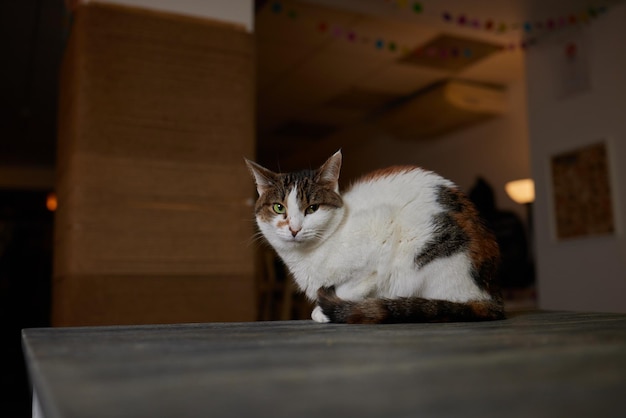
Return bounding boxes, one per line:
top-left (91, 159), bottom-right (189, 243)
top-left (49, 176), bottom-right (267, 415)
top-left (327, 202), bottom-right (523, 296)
top-left (246, 150), bottom-right (504, 323)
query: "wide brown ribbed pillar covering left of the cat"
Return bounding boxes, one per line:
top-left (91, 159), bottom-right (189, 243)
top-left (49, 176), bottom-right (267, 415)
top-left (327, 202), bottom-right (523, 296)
top-left (53, 3), bottom-right (255, 326)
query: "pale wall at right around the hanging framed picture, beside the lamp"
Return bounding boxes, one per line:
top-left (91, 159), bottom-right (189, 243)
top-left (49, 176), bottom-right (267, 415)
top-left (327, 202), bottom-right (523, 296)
top-left (526, 4), bottom-right (626, 312)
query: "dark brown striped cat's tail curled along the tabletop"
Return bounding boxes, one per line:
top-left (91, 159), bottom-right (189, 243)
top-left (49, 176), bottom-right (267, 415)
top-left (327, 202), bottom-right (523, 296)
top-left (317, 287), bottom-right (504, 324)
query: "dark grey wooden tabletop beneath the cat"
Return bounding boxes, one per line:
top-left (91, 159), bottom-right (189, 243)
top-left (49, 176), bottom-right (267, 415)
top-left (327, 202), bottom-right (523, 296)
top-left (23, 312), bottom-right (626, 418)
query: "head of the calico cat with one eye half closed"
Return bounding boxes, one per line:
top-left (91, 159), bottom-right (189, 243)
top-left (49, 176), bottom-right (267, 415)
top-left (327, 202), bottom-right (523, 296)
top-left (246, 151), bottom-right (343, 250)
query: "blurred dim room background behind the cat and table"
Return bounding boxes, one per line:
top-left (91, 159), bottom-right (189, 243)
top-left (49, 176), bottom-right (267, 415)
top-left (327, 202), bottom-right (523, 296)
top-left (0, 0), bottom-right (626, 417)
